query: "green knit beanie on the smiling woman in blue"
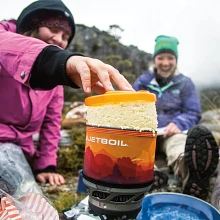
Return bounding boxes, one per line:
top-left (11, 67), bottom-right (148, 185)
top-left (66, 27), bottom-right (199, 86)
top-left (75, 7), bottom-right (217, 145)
top-left (153, 35), bottom-right (179, 59)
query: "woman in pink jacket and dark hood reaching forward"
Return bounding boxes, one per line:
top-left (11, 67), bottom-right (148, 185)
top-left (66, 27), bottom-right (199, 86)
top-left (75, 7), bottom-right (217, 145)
top-left (0, 0), bottom-right (133, 196)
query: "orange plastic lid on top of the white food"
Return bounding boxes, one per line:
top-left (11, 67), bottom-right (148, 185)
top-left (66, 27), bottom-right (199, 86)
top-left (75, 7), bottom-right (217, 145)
top-left (85, 90), bottom-right (156, 106)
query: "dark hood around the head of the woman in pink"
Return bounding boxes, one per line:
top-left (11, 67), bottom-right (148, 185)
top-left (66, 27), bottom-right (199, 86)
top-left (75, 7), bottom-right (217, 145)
top-left (16, 0), bottom-right (75, 45)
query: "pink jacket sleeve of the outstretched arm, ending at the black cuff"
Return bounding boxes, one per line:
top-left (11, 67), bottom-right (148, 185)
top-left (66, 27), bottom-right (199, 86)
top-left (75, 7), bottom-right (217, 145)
top-left (0, 20), bottom-right (48, 85)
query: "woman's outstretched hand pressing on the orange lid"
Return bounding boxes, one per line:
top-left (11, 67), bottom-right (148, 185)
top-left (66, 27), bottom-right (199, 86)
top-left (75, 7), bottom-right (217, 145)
top-left (66, 56), bottom-right (134, 94)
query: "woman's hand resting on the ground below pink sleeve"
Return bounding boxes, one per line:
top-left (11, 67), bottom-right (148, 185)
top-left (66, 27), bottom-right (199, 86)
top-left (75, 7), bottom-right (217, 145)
top-left (36, 173), bottom-right (66, 186)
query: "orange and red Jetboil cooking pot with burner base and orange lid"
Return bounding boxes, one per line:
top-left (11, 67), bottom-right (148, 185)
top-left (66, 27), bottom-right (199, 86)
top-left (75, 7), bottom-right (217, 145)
top-left (83, 91), bottom-right (157, 218)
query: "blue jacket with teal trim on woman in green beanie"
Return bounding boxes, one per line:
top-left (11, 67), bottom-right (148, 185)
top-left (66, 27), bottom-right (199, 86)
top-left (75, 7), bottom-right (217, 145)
top-left (133, 71), bottom-right (201, 131)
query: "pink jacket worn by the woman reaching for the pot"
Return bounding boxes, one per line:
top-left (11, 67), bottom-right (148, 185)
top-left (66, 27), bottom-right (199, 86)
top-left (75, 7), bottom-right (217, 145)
top-left (0, 21), bottom-right (63, 170)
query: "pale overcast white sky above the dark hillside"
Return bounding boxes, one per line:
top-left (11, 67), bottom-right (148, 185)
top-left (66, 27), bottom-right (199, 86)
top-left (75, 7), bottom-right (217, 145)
top-left (0, 0), bottom-right (220, 86)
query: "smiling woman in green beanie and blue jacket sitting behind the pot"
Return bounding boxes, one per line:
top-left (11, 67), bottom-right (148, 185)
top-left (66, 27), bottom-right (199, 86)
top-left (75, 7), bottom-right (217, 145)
top-left (133, 35), bottom-right (218, 201)
